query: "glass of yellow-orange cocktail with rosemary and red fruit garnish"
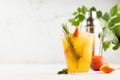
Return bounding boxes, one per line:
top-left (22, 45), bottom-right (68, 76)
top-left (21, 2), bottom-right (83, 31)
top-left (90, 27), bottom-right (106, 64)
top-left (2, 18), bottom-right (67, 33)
top-left (62, 27), bottom-right (94, 73)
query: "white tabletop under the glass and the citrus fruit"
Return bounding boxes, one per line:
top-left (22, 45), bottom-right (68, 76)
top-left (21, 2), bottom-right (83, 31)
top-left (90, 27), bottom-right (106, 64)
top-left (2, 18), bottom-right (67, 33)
top-left (0, 64), bottom-right (120, 80)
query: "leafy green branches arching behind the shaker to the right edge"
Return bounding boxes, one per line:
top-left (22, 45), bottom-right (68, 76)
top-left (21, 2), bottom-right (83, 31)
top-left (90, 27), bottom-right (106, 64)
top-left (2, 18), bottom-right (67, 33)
top-left (68, 4), bottom-right (120, 51)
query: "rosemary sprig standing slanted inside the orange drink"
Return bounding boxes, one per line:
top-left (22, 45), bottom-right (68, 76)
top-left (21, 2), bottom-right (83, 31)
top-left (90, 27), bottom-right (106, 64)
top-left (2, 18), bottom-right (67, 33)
top-left (62, 24), bottom-right (80, 61)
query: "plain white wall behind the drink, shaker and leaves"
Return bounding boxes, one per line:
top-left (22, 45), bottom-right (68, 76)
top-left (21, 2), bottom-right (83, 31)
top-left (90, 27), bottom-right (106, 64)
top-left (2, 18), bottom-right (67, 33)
top-left (0, 0), bottom-right (120, 64)
